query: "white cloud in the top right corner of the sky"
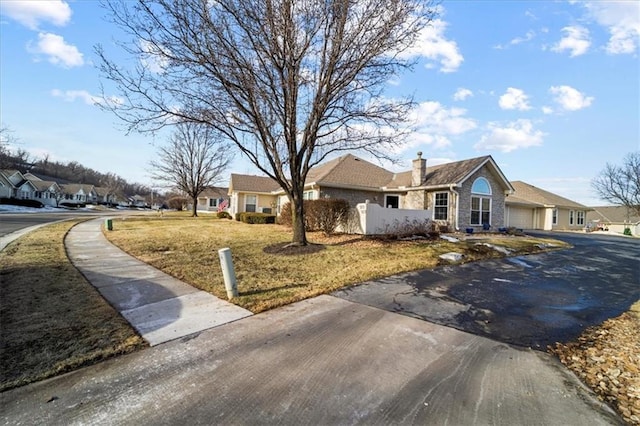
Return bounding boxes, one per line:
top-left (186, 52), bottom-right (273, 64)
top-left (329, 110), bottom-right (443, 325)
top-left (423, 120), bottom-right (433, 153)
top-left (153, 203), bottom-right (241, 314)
top-left (584, 1), bottom-right (640, 55)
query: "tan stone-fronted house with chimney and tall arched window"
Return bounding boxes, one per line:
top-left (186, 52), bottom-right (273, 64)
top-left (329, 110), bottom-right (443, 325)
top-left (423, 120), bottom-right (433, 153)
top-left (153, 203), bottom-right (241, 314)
top-left (229, 153), bottom-right (513, 229)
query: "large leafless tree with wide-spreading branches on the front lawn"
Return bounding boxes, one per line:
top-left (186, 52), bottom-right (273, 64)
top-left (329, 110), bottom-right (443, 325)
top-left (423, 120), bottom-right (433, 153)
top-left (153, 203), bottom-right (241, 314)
top-left (96, 0), bottom-right (437, 245)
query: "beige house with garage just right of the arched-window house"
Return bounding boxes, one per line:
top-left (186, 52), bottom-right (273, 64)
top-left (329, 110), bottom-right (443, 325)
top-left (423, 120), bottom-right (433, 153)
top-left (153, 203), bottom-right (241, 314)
top-left (505, 181), bottom-right (591, 231)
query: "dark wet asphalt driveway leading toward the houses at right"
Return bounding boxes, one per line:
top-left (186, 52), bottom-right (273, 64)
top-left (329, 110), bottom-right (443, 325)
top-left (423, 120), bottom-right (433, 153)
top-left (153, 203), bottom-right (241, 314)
top-left (334, 233), bottom-right (640, 350)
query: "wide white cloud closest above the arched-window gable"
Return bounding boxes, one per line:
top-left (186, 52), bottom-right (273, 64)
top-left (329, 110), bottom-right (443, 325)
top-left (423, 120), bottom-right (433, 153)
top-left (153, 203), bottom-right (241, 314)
top-left (473, 119), bottom-right (545, 152)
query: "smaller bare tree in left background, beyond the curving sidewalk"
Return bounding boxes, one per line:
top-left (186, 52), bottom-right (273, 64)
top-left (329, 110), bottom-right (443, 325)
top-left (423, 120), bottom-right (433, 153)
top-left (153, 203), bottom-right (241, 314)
top-left (151, 122), bottom-right (233, 217)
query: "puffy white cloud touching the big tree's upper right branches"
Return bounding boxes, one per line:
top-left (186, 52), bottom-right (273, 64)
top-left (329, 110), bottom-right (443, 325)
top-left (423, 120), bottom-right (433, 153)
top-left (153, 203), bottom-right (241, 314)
top-left (400, 19), bottom-right (464, 73)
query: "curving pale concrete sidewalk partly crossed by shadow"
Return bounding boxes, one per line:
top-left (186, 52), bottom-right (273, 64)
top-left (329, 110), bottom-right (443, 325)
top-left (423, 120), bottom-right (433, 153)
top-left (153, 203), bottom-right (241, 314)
top-left (65, 218), bottom-right (252, 346)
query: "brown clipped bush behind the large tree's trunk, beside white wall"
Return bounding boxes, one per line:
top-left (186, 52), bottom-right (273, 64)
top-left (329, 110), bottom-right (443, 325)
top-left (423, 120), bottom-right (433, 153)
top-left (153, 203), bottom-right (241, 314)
top-left (279, 198), bottom-right (350, 235)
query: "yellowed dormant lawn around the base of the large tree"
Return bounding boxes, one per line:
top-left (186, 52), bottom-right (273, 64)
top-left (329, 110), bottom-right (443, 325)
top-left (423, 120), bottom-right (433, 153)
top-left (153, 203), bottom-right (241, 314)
top-left (106, 215), bottom-right (567, 313)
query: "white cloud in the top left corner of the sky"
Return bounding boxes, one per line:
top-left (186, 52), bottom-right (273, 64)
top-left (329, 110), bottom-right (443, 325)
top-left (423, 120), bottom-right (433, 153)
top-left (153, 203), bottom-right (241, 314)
top-left (2, 0), bottom-right (71, 30)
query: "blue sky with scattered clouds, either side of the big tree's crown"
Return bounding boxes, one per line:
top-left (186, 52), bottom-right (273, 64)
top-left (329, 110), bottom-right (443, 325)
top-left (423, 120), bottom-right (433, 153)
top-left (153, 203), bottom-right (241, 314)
top-left (0, 0), bottom-right (640, 206)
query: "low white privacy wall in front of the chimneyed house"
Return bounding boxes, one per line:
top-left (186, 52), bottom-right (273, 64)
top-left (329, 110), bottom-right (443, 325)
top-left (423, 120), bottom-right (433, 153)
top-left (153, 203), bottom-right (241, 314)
top-left (351, 202), bottom-right (432, 235)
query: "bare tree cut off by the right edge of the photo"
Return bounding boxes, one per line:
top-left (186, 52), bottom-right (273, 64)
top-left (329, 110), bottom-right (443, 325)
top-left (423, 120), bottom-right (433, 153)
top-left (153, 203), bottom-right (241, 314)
top-left (591, 151), bottom-right (640, 216)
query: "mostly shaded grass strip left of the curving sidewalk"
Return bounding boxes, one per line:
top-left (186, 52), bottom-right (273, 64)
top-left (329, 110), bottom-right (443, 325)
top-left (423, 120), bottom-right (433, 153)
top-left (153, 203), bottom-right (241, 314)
top-left (0, 221), bottom-right (146, 391)
